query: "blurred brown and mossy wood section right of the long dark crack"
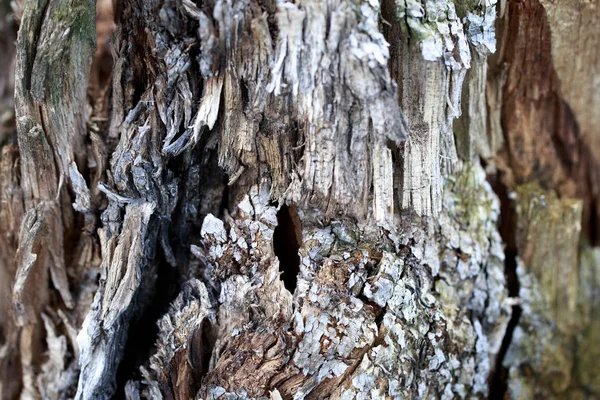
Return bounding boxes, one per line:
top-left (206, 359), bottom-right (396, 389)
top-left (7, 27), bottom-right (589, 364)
top-left (488, 0), bottom-right (600, 399)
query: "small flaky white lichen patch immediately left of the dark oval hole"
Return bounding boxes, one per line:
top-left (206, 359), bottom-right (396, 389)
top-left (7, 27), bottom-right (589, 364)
top-left (193, 185), bottom-right (292, 398)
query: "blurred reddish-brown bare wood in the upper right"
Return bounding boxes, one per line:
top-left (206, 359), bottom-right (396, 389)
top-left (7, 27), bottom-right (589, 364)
top-left (489, 0), bottom-right (600, 243)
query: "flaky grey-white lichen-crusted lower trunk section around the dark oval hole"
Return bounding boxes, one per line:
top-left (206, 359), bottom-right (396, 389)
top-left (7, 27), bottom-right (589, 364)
top-left (130, 166), bottom-right (510, 399)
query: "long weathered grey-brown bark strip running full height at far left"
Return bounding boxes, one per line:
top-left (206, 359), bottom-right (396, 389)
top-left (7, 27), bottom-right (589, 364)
top-left (5, 1), bottom-right (95, 398)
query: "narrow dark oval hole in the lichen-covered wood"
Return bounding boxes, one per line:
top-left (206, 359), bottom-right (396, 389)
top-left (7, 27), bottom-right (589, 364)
top-left (273, 204), bottom-right (302, 293)
